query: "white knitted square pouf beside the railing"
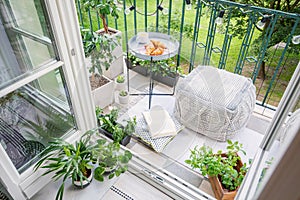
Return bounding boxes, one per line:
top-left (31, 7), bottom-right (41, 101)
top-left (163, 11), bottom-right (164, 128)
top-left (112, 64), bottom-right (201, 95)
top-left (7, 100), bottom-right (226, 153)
top-left (175, 66), bottom-right (256, 141)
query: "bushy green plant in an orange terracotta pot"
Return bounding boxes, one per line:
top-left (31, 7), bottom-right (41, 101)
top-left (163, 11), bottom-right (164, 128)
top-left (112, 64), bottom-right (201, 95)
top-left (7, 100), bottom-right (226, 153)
top-left (185, 140), bottom-right (247, 199)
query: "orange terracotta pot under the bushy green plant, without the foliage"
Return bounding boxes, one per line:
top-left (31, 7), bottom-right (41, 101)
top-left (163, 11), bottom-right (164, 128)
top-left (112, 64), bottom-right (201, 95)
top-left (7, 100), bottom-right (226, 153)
top-left (208, 154), bottom-right (243, 200)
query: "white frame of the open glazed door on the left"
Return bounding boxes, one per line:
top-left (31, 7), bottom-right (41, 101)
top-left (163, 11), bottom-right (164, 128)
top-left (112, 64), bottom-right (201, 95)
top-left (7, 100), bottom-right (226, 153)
top-left (0, 0), bottom-right (96, 200)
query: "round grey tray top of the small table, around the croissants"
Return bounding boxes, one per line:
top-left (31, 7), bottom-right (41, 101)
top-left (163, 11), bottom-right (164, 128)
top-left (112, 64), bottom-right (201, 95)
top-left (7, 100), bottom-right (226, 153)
top-left (128, 32), bottom-right (179, 61)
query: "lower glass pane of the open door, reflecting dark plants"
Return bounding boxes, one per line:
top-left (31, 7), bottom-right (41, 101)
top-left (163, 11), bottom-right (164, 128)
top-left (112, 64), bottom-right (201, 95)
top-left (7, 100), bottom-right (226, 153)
top-left (0, 69), bottom-right (76, 172)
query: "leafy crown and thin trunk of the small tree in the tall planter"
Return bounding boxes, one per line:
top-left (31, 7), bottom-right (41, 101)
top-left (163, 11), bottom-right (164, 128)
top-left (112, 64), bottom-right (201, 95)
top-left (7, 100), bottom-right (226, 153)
top-left (83, 0), bottom-right (119, 33)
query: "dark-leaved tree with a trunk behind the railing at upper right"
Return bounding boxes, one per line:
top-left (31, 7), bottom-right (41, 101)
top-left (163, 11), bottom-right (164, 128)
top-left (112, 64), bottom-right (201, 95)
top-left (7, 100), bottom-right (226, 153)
top-left (230, 0), bottom-right (300, 79)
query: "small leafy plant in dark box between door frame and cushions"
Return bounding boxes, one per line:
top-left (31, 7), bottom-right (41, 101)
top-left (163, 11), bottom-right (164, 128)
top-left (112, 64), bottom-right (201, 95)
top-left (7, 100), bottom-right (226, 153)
top-left (96, 107), bottom-right (136, 146)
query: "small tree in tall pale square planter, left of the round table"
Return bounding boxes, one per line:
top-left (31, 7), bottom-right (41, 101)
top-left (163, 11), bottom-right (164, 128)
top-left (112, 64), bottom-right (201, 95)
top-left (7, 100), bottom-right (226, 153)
top-left (83, 0), bottom-right (123, 79)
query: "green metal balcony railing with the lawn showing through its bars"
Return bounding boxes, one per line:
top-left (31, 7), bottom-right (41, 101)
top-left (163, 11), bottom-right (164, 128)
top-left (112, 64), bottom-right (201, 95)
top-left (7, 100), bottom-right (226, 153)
top-left (76, 0), bottom-right (300, 109)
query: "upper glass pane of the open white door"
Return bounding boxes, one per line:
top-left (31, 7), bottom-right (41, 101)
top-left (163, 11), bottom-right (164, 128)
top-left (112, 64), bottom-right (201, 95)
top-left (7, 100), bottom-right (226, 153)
top-left (0, 0), bottom-right (57, 88)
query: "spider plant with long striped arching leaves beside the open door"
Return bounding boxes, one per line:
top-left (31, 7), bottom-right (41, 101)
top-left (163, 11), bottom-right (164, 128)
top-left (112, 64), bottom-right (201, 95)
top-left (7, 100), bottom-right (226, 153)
top-left (34, 132), bottom-right (93, 199)
